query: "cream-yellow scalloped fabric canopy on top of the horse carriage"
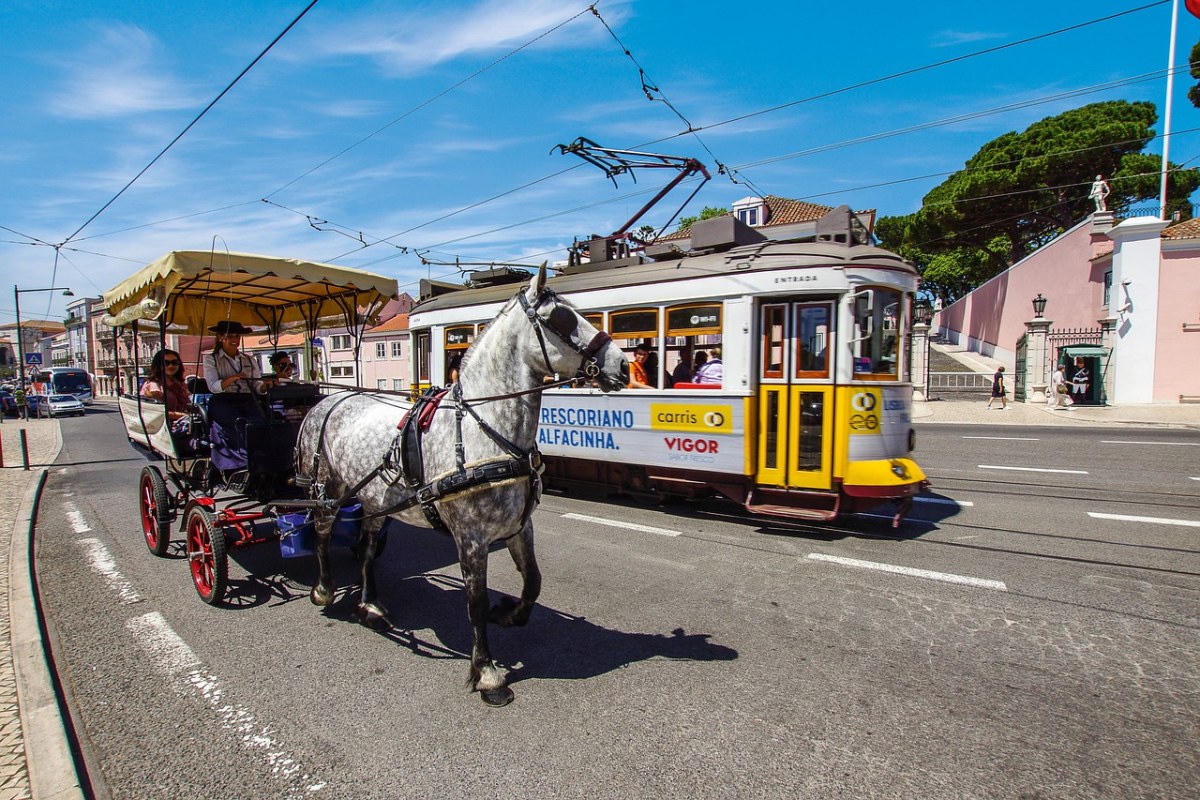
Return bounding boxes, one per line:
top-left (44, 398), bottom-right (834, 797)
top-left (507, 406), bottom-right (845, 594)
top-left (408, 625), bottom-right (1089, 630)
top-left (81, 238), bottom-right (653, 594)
top-left (104, 251), bottom-right (400, 333)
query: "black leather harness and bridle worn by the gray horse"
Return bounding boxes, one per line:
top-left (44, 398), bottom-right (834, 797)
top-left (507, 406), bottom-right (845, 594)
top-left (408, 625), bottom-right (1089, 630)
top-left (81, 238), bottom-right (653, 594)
top-left (304, 289), bottom-right (611, 530)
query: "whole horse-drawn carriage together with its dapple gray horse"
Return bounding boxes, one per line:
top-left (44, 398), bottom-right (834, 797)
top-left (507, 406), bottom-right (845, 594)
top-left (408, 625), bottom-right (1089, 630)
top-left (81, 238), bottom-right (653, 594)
top-left (106, 253), bottom-right (629, 705)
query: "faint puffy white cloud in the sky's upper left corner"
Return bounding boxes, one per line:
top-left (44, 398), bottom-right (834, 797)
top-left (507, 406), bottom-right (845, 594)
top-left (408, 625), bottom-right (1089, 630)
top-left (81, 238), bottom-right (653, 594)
top-left (48, 24), bottom-right (198, 120)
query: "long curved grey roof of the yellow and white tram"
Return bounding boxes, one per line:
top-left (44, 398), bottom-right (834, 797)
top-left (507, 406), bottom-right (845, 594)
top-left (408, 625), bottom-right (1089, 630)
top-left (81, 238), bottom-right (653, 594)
top-left (410, 241), bottom-right (917, 314)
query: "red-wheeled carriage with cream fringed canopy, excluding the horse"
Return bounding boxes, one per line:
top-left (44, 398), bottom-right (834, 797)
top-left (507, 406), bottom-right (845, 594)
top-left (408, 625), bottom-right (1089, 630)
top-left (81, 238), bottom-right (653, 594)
top-left (104, 252), bottom-right (397, 603)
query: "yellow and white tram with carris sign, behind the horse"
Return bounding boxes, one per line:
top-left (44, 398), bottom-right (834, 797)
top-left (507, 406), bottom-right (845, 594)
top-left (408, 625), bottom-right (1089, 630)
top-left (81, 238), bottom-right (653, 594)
top-left (409, 217), bottom-right (928, 522)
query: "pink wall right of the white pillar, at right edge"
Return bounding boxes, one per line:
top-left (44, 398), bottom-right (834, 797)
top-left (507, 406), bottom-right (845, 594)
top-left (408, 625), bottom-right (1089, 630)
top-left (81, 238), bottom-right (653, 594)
top-left (1154, 248), bottom-right (1200, 403)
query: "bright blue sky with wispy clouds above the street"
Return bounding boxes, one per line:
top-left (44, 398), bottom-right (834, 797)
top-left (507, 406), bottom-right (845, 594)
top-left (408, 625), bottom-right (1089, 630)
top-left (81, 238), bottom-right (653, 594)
top-left (0, 0), bottom-right (1200, 323)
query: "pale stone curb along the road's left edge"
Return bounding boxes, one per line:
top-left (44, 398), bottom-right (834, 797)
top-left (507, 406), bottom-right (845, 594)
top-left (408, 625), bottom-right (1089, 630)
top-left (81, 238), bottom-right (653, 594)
top-left (8, 428), bottom-right (85, 800)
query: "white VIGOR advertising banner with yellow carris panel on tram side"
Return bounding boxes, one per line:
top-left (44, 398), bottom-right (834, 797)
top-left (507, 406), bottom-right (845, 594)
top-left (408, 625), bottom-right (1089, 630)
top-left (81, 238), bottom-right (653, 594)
top-left (538, 391), bottom-right (745, 474)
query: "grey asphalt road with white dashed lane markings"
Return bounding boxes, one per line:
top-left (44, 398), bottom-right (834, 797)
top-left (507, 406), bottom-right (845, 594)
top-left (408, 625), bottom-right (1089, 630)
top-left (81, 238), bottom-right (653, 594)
top-left (36, 413), bottom-right (1200, 800)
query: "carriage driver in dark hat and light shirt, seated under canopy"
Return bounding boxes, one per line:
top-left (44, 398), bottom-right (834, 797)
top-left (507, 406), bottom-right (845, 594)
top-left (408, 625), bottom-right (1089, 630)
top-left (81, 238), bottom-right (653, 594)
top-left (204, 319), bottom-right (265, 480)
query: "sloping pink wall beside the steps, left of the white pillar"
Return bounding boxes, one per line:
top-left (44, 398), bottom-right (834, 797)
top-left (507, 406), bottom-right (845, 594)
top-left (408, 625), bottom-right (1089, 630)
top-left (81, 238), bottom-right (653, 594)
top-left (934, 218), bottom-right (1112, 368)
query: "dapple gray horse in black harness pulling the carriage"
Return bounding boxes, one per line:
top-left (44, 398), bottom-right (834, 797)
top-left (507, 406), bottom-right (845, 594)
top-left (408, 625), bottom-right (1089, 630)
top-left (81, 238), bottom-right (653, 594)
top-left (296, 265), bottom-right (629, 705)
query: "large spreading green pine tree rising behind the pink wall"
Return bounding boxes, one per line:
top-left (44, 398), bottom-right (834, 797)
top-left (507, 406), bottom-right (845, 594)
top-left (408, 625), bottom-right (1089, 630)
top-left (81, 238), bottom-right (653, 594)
top-left (876, 101), bottom-right (1200, 301)
